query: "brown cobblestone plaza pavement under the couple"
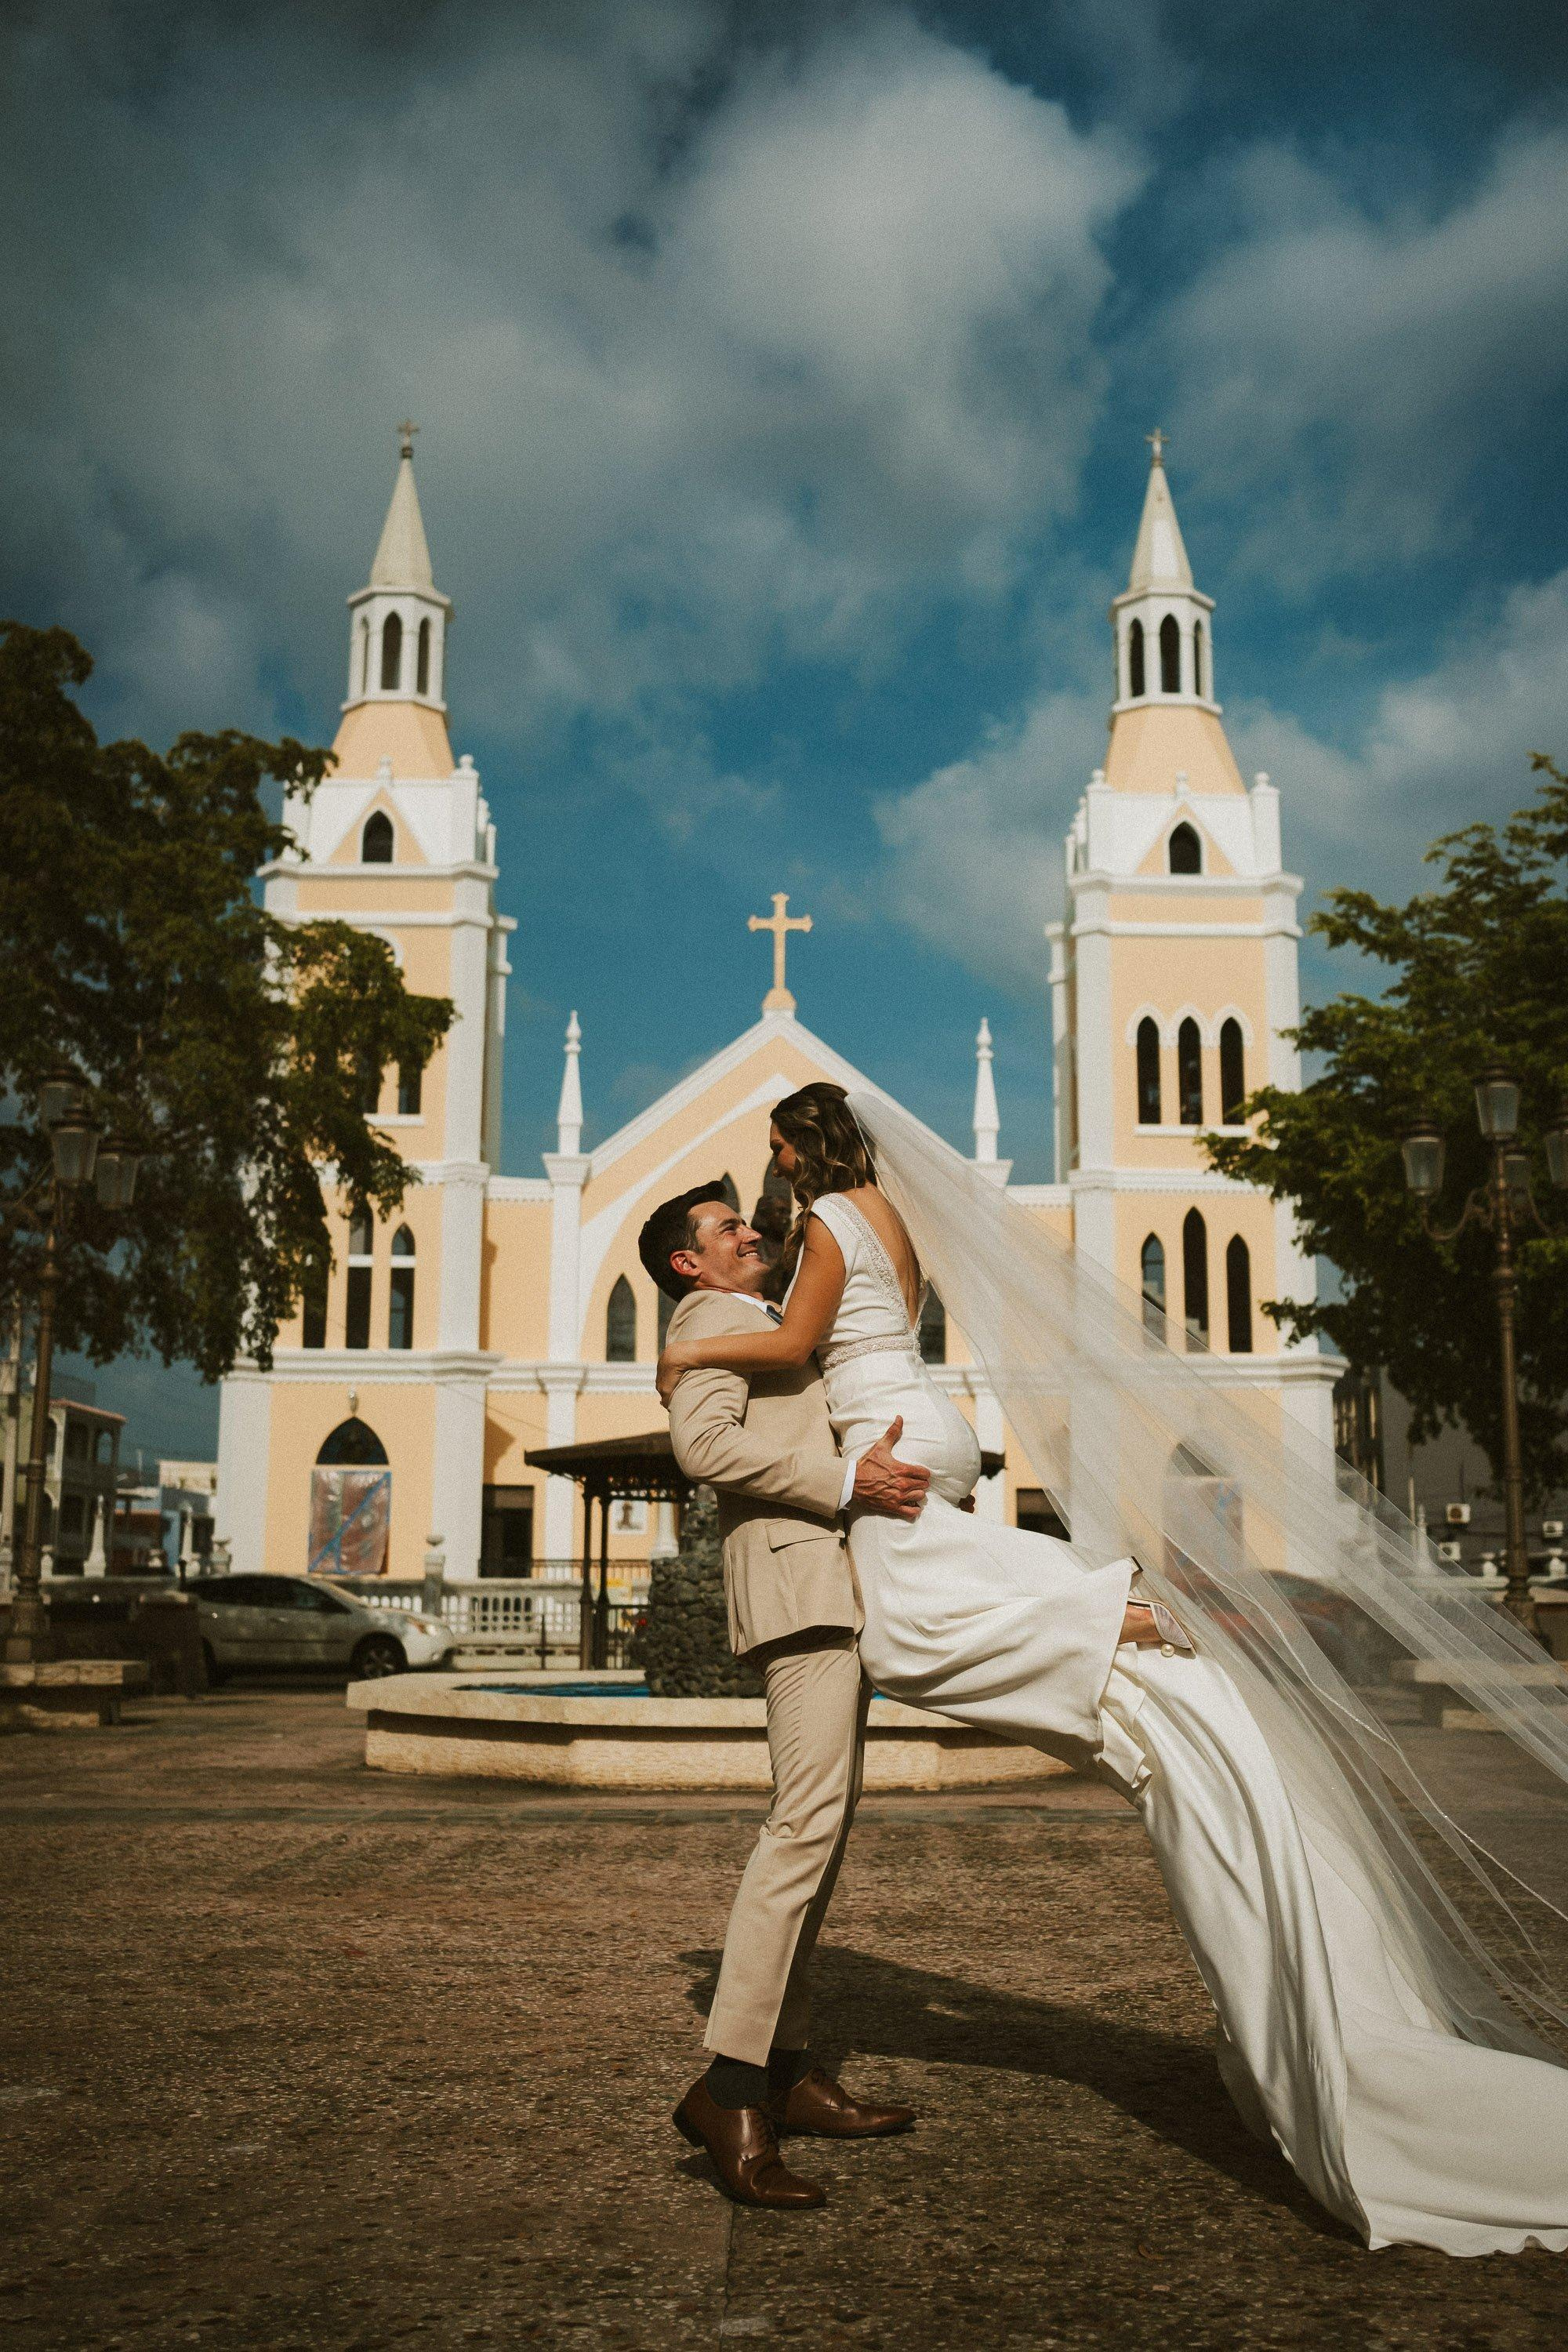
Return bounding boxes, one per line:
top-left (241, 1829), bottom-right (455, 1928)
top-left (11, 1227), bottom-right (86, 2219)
top-left (0, 1686), bottom-right (1568, 2352)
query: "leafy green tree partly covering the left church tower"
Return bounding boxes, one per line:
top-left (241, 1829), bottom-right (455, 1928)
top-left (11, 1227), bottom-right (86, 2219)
top-left (0, 623), bottom-right (452, 1378)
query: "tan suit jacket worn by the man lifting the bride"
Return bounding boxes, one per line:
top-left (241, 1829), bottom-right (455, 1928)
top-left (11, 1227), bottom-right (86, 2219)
top-left (670, 1291), bottom-right (862, 1653)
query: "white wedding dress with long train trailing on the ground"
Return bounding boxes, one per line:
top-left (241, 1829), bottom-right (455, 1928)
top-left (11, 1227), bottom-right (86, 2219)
top-left (813, 1195), bottom-right (1568, 2253)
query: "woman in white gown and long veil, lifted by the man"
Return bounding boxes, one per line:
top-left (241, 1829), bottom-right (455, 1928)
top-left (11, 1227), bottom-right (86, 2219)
top-left (659, 1084), bottom-right (1568, 2253)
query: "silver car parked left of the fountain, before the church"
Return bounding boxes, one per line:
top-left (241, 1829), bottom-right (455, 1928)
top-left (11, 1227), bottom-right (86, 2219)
top-left (186, 1576), bottom-right (454, 1684)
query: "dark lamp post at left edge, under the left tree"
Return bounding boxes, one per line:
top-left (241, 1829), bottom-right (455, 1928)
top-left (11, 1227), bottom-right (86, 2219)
top-left (5, 1070), bottom-right (141, 1665)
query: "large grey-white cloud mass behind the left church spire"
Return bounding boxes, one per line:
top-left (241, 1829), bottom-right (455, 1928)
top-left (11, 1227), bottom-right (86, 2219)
top-left (0, 0), bottom-right (1135, 729)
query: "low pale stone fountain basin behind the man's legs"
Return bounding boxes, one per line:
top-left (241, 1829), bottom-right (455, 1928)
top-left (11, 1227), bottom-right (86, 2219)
top-left (348, 1668), bottom-right (1067, 1795)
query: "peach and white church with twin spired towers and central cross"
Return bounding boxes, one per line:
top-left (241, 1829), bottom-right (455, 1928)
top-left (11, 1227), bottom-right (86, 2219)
top-left (216, 428), bottom-right (1342, 1585)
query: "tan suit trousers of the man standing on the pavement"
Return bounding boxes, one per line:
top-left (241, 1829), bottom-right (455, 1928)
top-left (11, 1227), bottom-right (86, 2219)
top-left (706, 1628), bottom-right (872, 2065)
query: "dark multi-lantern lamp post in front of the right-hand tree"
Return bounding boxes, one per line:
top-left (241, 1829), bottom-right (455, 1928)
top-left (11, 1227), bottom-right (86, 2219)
top-left (1401, 1070), bottom-right (1568, 1632)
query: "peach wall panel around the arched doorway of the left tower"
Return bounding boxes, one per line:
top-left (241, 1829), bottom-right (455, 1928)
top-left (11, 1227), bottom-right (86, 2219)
top-left (266, 1374), bottom-right (435, 1576)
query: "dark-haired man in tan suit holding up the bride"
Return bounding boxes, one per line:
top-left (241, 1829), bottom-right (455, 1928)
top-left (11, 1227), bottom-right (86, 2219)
top-left (637, 1181), bottom-right (928, 2206)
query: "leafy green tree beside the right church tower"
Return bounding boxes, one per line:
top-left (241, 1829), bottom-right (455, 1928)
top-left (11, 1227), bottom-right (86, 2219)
top-left (1203, 755), bottom-right (1568, 1501)
